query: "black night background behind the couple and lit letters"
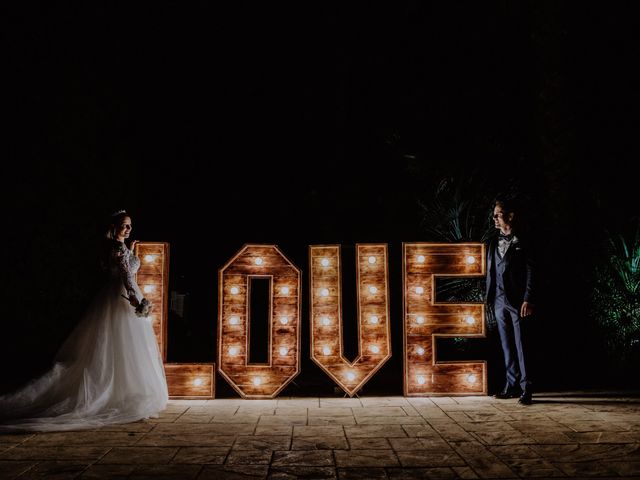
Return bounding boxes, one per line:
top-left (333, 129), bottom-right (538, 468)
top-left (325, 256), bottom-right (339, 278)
top-left (0, 0), bottom-right (640, 395)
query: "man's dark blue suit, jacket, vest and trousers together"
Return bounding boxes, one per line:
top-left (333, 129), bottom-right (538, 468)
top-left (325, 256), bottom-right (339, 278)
top-left (486, 234), bottom-right (536, 392)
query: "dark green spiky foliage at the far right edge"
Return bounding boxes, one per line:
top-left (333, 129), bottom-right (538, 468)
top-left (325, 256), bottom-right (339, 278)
top-left (591, 222), bottom-right (640, 365)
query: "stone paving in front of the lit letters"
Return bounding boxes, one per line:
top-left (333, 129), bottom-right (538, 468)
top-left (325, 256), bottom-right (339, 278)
top-left (0, 393), bottom-right (640, 480)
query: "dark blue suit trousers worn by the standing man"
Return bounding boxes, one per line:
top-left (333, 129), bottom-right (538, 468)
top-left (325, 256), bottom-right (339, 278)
top-left (494, 295), bottom-right (531, 391)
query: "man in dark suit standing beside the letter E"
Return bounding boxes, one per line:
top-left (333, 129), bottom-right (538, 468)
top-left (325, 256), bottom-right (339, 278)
top-left (486, 199), bottom-right (535, 405)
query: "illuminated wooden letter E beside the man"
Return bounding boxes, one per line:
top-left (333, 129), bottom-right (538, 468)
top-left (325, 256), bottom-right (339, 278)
top-left (403, 243), bottom-right (487, 396)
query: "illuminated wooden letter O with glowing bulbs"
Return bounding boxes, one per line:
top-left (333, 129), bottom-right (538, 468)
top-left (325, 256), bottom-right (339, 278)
top-left (218, 245), bottom-right (301, 398)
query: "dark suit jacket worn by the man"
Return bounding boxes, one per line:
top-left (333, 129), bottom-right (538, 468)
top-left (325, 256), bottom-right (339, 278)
top-left (486, 233), bottom-right (536, 309)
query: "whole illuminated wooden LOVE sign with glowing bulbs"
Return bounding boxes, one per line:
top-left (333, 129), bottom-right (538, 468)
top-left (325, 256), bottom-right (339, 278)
top-left (136, 242), bottom-right (487, 398)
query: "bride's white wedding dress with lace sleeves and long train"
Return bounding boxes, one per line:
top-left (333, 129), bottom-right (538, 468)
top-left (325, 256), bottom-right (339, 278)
top-left (0, 241), bottom-right (168, 432)
